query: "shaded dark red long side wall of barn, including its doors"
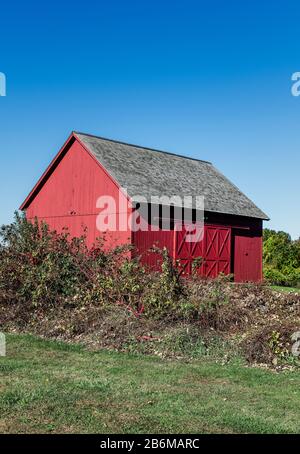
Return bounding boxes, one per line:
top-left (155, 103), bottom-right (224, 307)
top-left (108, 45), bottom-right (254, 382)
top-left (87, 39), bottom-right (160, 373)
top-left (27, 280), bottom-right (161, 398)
top-left (133, 213), bottom-right (262, 282)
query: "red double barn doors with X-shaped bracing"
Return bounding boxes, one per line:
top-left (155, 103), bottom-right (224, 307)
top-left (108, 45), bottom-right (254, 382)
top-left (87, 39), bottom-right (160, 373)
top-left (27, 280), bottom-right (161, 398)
top-left (174, 225), bottom-right (231, 277)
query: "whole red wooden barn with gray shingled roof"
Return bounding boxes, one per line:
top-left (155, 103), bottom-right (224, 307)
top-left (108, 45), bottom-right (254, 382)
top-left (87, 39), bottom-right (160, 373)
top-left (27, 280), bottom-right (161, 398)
top-left (20, 132), bottom-right (268, 282)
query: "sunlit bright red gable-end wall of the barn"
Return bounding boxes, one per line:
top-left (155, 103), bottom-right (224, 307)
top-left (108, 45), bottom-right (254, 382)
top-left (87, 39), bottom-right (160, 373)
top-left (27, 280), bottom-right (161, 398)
top-left (26, 140), bottom-right (131, 247)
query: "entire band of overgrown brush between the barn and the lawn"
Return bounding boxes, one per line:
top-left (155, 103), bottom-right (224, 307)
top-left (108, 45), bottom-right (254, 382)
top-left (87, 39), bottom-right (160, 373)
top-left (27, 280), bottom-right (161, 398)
top-left (0, 215), bottom-right (300, 370)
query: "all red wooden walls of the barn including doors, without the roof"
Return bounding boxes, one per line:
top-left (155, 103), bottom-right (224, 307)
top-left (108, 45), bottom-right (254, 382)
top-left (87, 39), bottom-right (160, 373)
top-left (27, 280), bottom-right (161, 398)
top-left (21, 136), bottom-right (262, 282)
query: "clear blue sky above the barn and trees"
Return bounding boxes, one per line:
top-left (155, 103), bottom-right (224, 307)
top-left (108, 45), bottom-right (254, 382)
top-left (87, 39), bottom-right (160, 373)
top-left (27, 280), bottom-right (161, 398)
top-left (0, 0), bottom-right (300, 238)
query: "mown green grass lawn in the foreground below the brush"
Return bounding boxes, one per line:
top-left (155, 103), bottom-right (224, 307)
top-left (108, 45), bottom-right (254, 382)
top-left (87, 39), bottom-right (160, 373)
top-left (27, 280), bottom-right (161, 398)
top-left (0, 335), bottom-right (300, 433)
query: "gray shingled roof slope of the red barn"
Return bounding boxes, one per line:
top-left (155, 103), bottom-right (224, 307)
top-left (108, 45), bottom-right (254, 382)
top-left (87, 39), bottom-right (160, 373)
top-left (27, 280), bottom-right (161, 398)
top-left (74, 132), bottom-right (268, 219)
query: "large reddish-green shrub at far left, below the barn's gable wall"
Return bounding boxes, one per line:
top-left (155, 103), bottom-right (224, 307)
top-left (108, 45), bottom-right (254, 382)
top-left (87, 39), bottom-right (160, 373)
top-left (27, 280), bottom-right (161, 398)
top-left (0, 214), bottom-right (132, 307)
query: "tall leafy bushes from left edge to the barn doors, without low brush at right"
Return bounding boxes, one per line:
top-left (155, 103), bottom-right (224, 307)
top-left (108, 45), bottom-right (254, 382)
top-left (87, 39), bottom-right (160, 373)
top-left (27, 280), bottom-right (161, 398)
top-left (0, 214), bottom-right (184, 318)
